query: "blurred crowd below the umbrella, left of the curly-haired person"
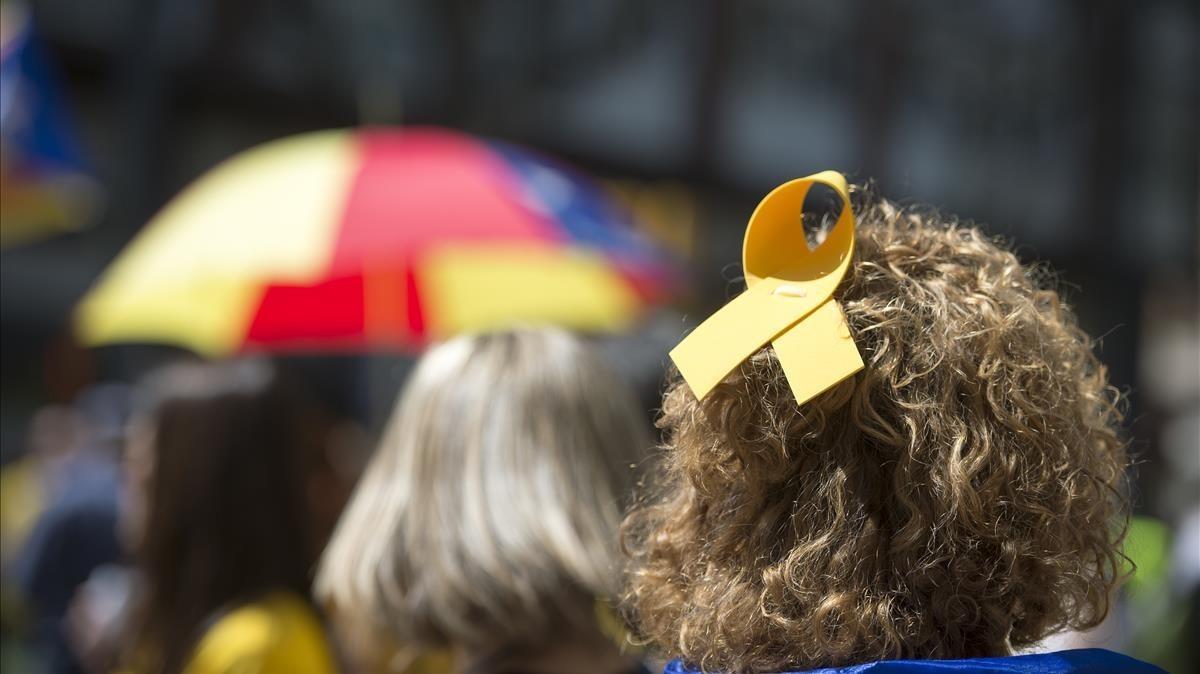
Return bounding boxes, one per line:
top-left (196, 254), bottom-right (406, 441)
top-left (2, 330), bottom-right (650, 673)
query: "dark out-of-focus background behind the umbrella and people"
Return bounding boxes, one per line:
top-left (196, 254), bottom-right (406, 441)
top-left (0, 0), bottom-right (1200, 672)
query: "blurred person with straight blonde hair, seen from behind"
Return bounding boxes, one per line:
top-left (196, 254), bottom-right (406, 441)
top-left (317, 330), bottom-right (649, 674)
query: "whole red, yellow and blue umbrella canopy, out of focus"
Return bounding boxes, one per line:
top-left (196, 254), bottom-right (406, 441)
top-left (76, 128), bottom-right (673, 355)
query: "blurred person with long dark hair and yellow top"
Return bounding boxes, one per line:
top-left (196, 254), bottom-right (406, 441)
top-left (88, 360), bottom-right (336, 674)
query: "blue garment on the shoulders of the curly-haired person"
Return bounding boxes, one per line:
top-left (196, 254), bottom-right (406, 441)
top-left (662, 649), bottom-right (1166, 674)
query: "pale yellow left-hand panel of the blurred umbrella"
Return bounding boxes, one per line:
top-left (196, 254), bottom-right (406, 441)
top-left (76, 131), bottom-right (358, 355)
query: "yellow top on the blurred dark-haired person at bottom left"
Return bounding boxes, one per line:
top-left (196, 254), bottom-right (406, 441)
top-left (184, 594), bottom-right (337, 674)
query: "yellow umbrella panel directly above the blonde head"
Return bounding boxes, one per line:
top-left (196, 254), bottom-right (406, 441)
top-left (418, 246), bottom-right (638, 337)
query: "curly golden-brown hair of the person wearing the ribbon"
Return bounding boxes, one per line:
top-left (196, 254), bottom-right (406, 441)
top-left (624, 185), bottom-right (1128, 672)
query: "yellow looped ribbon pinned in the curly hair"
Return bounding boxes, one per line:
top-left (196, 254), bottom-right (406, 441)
top-left (671, 170), bottom-right (863, 404)
